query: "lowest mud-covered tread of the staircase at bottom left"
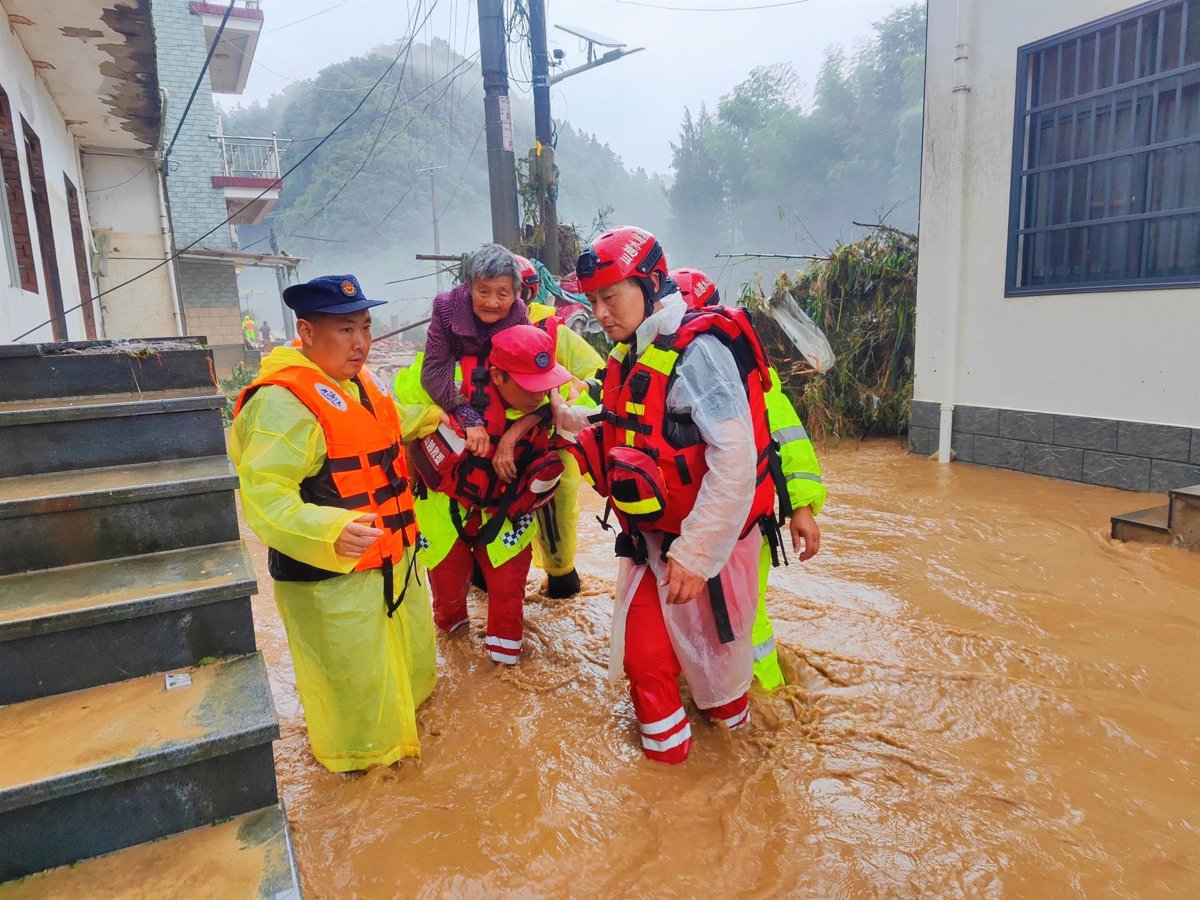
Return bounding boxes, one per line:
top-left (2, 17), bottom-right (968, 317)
top-left (0, 806), bottom-right (300, 900)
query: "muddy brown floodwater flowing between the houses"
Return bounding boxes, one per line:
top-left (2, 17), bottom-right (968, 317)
top-left (247, 442), bottom-right (1200, 898)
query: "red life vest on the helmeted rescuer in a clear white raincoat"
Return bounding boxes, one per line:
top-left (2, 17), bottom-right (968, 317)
top-left (600, 306), bottom-right (776, 536)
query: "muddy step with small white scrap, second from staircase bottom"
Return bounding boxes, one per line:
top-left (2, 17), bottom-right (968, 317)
top-left (0, 654), bottom-right (280, 881)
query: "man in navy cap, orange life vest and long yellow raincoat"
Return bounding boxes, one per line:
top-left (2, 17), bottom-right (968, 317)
top-left (229, 276), bottom-right (437, 772)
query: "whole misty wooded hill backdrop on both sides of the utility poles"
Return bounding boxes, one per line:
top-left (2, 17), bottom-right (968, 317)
top-left (226, 4), bottom-right (925, 309)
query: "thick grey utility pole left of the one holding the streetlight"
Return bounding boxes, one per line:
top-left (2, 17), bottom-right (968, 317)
top-left (479, 0), bottom-right (518, 248)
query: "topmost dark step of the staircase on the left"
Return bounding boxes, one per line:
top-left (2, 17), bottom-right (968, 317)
top-left (0, 337), bottom-right (217, 402)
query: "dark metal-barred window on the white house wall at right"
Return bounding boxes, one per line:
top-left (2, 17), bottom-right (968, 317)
top-left (1004, 0), bottom-right (1200, 298)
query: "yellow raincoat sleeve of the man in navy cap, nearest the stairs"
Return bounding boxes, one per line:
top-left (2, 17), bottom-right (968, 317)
top-left (229, 385), bottom-right (360, 572)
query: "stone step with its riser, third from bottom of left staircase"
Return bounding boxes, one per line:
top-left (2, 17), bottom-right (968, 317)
top-left (0, 541), bottom-right (257, 704)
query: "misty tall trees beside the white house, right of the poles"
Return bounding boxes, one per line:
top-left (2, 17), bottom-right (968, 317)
top-left (668, 4), bottom-right (925, 267)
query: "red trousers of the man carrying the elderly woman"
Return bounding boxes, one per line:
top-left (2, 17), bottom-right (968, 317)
top-left (430, 532), bottom-right (533, 666)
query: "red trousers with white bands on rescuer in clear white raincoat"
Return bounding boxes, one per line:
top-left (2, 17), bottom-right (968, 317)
top-left (624, 568), bottom-right (750, 763)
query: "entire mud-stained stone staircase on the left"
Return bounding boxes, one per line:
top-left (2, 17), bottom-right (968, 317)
top-left (0, 338), bottom-right (299, 900)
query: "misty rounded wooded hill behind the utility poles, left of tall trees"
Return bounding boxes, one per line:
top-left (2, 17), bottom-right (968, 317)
top-left (224, 40), bottom-right (668, 294)
